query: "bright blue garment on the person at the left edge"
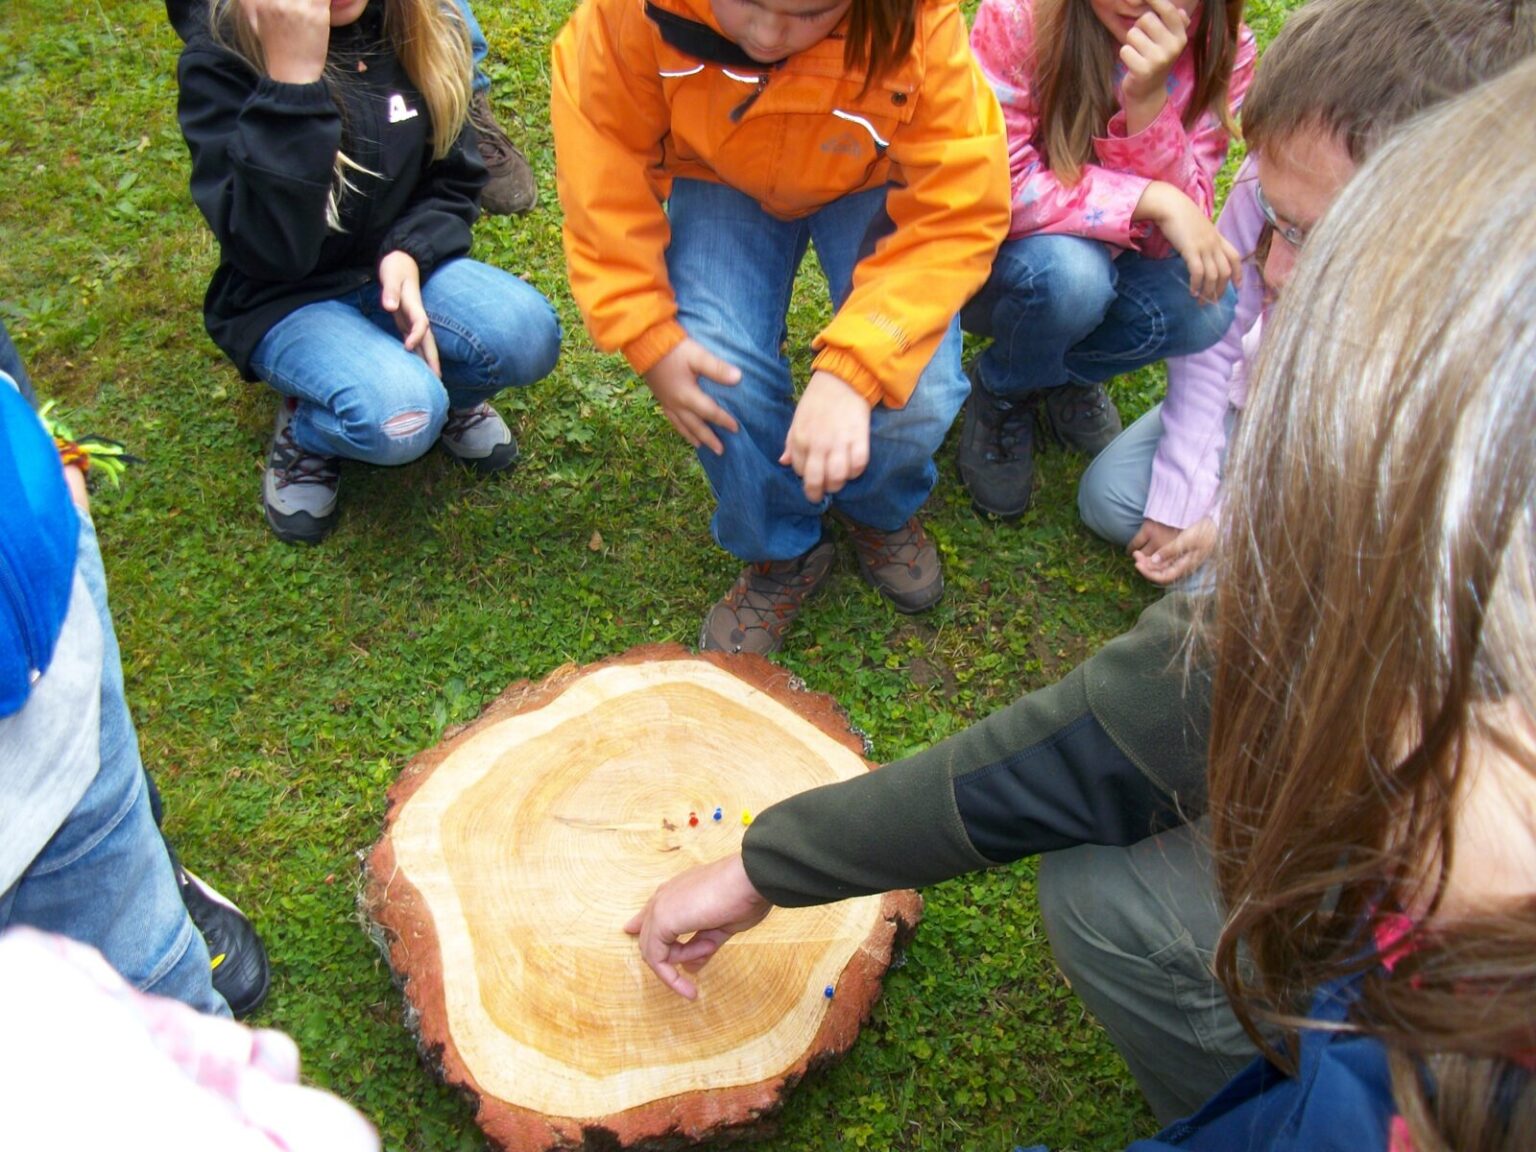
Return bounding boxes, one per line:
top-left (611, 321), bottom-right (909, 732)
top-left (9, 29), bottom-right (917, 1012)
top-left (0, 375), bottom-right (80, 716)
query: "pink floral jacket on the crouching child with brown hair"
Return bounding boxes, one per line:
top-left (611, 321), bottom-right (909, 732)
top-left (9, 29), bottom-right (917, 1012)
top-left (971, 0), bottom-right (1256, 257)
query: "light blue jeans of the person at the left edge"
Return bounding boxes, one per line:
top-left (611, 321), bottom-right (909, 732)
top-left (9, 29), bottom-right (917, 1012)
top-left (0, 516), bottom-right (229, 1015)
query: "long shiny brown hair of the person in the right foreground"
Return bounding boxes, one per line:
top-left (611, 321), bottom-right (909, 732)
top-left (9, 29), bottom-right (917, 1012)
top-left (1200, 60), bottom-right (1536, 1152)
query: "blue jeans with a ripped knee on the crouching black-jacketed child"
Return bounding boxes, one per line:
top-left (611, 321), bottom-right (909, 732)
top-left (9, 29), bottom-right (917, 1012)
top-left (250, 260), bottom-right (561, 464)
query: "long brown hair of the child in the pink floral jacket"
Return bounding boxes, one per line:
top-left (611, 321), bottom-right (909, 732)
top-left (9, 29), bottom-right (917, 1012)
top-left (1034, 0), bottom-right (1243, 184)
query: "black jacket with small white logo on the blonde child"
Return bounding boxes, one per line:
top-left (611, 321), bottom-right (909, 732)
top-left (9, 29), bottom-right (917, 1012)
top-left (177, 3), bottom-right (485, 379)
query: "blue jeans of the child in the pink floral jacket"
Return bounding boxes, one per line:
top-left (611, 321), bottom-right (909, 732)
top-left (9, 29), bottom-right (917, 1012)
top-left (960, 235), bottom-right (1236, 396)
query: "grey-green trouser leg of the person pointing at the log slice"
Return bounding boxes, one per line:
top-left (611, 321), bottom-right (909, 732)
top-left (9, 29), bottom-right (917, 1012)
top-left (1038, 820), bottom-right (1256, 1124)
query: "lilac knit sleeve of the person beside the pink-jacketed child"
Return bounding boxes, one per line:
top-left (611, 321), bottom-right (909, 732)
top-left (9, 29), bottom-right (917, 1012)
top-left (1144, 158), bottom-right (1264, 528)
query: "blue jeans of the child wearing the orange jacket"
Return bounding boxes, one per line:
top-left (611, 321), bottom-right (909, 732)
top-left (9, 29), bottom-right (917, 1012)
top-left (667, 180), bottom-right (969, 562)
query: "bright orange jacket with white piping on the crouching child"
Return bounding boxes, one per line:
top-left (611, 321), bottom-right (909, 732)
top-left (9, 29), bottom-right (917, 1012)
top-left (551, 0), bottom-right (1009, 407)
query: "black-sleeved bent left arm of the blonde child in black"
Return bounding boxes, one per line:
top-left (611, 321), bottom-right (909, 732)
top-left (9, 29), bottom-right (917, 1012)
top-left (177, 15), bottom-right (341, 281)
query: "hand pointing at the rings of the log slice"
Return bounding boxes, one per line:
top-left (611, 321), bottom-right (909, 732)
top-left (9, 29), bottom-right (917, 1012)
top-left (624, 852), bottom-right (773, 1000)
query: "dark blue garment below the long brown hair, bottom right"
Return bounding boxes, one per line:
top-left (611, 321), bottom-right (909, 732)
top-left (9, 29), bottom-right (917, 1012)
top-left (1127, 977), bottom-right (1398, 1152)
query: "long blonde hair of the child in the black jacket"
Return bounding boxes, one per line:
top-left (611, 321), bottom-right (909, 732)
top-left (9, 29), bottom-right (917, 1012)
top-left (209, 0), bottom-right (470, 229)
